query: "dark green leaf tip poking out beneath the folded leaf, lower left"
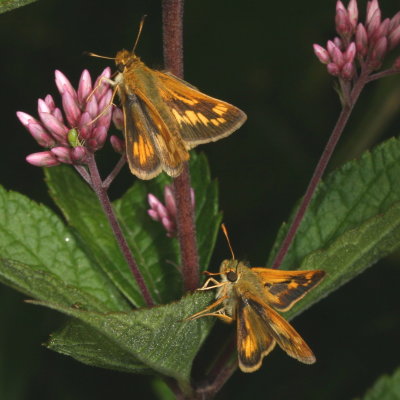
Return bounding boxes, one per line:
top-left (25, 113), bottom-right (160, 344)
top-left (46, 318), bottom-right (150, 373)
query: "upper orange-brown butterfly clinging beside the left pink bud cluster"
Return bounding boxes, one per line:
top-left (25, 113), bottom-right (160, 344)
top-left (101, 19), bottom-right (247, 179)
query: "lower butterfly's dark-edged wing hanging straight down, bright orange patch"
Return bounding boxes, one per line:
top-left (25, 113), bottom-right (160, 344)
top-left (236, 297), bottom-right (275, 372)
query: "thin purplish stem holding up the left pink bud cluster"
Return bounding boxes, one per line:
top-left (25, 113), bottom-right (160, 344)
top-left (88, 154), bottom-right (154, 306)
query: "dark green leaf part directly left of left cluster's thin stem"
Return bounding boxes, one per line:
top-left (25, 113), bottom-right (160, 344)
top-left (45, 166), bottom-right (144, 306)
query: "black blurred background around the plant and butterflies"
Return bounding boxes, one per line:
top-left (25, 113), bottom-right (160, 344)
top-left (0, 0), bottom-right (400, 400)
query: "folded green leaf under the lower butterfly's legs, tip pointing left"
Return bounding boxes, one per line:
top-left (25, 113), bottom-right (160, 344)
top-left (34, 292), bottom-right (214, 390)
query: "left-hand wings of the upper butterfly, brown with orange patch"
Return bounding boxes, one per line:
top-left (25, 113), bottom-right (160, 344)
top-left (118, 86), bottom-right (189, 179)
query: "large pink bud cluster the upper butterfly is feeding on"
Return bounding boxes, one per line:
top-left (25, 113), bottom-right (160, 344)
top-left (17, 68), bottom-right (112, 167)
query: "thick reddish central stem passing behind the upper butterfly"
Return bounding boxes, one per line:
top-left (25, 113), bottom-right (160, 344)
top-left (162, 0), bottom-right (199, 291)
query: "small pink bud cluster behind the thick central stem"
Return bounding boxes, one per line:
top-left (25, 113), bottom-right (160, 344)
top-left (147, 185), bottom-right (195, 237)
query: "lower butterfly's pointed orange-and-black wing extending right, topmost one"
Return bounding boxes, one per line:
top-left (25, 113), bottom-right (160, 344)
top-left (251, 268), bottom-right (325, 311)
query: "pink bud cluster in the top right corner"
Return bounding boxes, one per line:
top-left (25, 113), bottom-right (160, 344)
top-left (314, 0), bottom-right (400, 80)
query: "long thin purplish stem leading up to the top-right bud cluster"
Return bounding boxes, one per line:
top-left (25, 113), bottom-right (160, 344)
top-left (272, 69), bottom-right (369, 268)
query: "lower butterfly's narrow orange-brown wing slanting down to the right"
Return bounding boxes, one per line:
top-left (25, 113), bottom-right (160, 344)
top-left (246, 294), bottom-right (315, 364)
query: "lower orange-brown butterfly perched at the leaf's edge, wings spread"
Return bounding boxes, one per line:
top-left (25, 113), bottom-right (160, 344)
top-left (188, 225), bottom-right (325, 372)
